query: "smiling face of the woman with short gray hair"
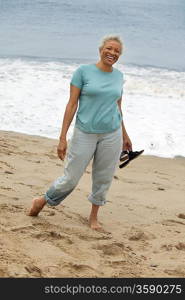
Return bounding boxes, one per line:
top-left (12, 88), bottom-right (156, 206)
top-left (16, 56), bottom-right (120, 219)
top-left (100, 40), bottom-right (121, 66)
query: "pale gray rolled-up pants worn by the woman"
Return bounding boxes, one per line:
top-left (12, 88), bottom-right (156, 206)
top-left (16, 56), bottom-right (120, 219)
top-left (44, 127), bottom-right (122, 206)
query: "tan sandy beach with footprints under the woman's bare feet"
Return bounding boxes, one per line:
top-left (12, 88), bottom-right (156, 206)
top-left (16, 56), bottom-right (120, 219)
top-left (0, 131), bottom-right (185, 278)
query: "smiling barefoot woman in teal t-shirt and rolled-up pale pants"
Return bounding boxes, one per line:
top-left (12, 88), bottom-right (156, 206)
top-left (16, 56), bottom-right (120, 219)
top-left (28, 36), bottom-right (132, 230)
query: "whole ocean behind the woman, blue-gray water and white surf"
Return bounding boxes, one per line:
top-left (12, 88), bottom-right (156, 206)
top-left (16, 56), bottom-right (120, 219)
top-left (0, 0), bottom-right (185, 157)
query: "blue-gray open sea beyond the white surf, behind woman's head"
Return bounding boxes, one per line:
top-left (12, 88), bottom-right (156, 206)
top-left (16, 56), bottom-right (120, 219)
top-left (0, 0), bottom-right (185, 70)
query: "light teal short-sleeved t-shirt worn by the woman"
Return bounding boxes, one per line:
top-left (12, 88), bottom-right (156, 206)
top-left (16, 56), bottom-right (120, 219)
top-left (71, 64), bottom-right (123, 133)
